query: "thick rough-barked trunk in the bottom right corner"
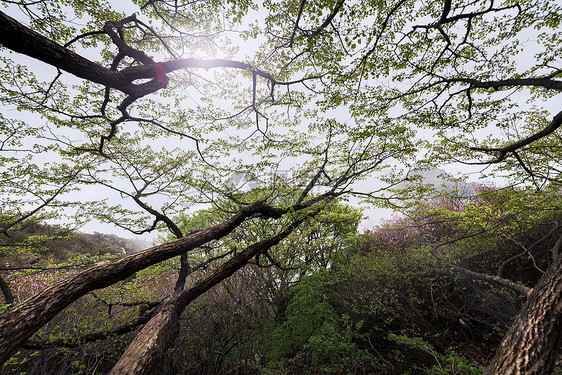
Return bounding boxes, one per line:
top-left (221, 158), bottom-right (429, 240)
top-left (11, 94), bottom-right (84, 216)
top-left (483, 257), bottom-right (562, 375)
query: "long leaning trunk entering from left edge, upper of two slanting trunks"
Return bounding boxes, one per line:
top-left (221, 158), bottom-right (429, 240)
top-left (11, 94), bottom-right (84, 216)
top-left (0, 202), bottom-right (285, 363)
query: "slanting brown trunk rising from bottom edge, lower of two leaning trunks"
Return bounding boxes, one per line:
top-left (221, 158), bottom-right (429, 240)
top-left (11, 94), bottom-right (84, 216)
top-left (109, 220), bottom-right (302, 375)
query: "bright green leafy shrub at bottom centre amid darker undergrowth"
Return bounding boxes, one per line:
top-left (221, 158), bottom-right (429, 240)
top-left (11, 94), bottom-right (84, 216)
top-left (264, 271), bottom-right (377, 374)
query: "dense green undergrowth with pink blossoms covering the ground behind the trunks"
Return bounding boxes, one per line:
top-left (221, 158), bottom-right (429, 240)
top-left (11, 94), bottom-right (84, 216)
top-left (3, 186), bottom-right (562, 374)
